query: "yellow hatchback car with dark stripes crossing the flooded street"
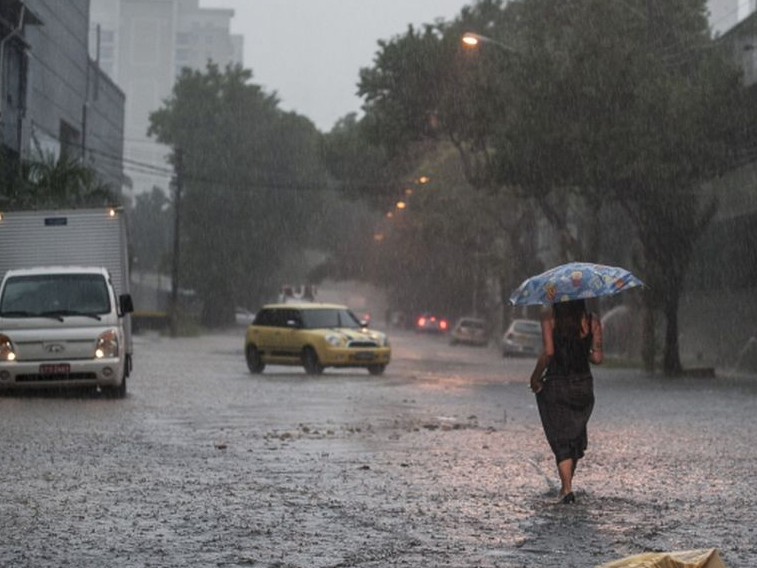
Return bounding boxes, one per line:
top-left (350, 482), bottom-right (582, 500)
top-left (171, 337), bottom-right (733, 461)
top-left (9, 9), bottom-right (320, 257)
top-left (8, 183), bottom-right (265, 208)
top-left (244, 302), bottom-right (391, 375)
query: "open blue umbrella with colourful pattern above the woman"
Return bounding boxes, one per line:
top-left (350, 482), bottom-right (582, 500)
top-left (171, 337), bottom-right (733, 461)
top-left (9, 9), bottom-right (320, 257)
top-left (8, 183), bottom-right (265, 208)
top-left (510, 262), bottom-right (644, 306)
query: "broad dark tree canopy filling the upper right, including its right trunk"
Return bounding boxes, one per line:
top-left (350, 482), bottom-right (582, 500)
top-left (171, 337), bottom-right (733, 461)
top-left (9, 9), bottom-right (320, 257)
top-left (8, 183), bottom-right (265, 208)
top-left (360, 0), bottom-right (751, 373)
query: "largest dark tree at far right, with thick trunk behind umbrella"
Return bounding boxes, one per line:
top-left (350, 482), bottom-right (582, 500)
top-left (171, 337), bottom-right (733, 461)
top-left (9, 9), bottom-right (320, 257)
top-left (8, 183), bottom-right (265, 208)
top-left (496, 0), bottom-right (746, 375)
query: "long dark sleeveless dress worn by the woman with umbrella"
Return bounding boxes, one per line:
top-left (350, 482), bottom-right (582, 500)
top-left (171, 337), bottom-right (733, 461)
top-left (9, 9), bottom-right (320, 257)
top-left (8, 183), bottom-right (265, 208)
top-left (536, 320), bottom-right (594, 463)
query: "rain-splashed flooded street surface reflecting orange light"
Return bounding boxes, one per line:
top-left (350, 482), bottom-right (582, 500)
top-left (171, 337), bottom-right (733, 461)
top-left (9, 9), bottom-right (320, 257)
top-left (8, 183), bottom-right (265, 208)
top-left (0, 329), bottom-right (757, 568)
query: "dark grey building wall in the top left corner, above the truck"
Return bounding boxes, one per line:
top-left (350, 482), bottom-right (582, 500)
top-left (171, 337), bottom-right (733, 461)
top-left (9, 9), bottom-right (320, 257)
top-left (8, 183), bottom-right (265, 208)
top-left (0, 0), bottom-right (125, 190)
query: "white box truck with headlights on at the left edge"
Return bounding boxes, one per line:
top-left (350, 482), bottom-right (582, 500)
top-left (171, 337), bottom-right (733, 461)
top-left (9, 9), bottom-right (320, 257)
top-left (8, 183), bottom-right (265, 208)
top-left (0, 208), bottom-right (134, 398)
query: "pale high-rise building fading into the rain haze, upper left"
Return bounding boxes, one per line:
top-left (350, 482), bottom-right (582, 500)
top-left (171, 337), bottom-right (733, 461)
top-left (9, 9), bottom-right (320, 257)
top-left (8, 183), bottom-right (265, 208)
top-left (90, 0), bottom-right (243, 193)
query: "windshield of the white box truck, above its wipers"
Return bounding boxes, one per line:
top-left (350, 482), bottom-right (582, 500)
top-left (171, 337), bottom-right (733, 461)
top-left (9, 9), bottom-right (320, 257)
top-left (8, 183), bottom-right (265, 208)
top-left (0, 274), bottom-right (110, 318)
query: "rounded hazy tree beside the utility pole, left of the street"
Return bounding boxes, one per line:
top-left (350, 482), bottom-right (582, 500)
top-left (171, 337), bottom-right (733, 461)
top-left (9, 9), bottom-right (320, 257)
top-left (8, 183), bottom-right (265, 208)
top-left (149, 64), bottom-right (327, 326)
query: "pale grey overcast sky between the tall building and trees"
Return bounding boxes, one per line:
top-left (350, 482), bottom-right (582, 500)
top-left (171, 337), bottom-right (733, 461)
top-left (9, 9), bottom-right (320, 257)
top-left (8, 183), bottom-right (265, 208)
top-left (195, 0), bottom-right (472, 131)
